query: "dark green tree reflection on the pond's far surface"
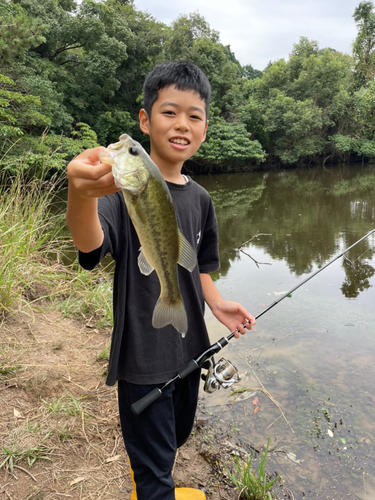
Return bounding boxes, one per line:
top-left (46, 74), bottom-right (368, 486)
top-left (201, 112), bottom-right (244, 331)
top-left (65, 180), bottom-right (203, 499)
top-left (195, 167), bottom-right (375, 297)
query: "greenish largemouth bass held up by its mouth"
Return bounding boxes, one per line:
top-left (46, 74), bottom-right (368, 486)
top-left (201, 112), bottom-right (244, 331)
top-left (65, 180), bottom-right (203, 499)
top-left (99, 134), bottom-right (197, 337)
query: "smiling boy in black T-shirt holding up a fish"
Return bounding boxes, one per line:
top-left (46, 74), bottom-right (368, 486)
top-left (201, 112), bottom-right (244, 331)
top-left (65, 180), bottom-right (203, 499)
top-left (67, 62), bottom-right (255, 500)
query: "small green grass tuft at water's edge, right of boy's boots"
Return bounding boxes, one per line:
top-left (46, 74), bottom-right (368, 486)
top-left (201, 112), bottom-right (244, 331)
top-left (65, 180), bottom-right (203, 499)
top-left (229, 440), bottom-right (279, 500)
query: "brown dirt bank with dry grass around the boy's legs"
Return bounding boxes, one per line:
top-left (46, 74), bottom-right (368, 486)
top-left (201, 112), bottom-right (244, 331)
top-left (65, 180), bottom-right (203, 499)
top-left (0, 308), bottom-right (294, 500)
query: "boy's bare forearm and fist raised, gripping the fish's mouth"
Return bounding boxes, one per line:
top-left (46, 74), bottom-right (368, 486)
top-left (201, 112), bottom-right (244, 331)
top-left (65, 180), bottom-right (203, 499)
top-left (66, 147), bottom-right (120, 253)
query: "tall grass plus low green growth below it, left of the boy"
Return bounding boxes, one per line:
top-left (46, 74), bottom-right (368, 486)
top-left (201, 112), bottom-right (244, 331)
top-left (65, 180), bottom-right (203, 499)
top-left (0, 172), bottom-right (113, 326)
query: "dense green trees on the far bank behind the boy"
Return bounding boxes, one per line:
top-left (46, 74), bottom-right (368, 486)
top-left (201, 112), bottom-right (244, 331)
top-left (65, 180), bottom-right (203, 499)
top-left (0, 0), bottom-right (375, 174)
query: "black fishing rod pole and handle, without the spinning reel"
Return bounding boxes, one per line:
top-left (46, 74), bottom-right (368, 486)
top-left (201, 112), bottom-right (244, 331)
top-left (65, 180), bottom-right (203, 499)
top-left (131, 228), bottom-right (375, 415)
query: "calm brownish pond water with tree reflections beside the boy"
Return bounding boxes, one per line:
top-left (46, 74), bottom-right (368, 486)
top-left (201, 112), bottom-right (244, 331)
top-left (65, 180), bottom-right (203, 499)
top-left (195, 166), bottom-right (375, 500)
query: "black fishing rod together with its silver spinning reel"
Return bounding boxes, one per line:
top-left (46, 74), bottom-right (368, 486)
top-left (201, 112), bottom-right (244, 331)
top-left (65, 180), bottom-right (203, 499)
top-left (131, 228), bottom-right (375, 415)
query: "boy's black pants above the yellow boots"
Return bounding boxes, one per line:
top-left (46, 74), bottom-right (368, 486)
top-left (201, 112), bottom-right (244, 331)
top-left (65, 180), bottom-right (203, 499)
top-left (118, 370), bottom-right (200, 500)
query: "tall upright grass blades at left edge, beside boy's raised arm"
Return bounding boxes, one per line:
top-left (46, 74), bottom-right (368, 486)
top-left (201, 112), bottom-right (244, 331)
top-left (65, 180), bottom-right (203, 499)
top-left (0, 175), bottom-right (64, 317)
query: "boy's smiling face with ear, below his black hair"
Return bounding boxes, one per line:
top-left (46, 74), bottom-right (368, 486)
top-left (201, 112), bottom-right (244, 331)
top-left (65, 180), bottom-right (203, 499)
top-left (139, 85), bottom-right (208, 168)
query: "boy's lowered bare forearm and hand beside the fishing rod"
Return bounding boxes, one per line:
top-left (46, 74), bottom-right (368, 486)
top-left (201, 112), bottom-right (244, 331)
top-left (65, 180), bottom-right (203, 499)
top-left (200, 273), bottom-right (255, 338)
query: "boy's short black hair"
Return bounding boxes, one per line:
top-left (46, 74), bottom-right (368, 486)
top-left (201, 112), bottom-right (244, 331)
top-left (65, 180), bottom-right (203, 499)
top-left (143, 61), bottom-right (211, 120)
